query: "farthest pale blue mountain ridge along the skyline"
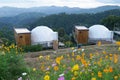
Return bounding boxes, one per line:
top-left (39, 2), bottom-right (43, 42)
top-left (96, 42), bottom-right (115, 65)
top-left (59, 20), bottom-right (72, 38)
top-left (0, 6), bottom-right (120, 17)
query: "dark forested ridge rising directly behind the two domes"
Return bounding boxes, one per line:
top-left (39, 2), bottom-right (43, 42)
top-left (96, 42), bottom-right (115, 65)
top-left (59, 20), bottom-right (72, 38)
top-left (28, 9), bottom-right (120, 33)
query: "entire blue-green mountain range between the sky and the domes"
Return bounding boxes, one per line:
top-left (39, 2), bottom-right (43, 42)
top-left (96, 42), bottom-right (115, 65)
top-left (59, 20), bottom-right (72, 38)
top-left (0, 6), bottom-right (120, 41)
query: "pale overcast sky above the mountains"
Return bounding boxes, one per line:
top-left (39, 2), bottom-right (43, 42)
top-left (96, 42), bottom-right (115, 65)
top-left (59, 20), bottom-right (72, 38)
top-left (0, 0), bottom-right (120, 8)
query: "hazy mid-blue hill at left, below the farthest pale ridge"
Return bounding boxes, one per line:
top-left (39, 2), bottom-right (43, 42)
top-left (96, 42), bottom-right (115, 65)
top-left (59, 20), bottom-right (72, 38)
top-left (0, 12), bottom-right (46, 26)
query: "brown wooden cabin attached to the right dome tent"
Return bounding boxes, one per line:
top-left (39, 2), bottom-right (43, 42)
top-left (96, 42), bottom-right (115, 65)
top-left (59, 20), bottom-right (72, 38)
top-left (75, 26), bottom-right (89, 44)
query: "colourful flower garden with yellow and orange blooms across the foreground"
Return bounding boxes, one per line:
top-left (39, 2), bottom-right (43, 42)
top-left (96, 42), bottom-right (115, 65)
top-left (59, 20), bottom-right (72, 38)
top-left (0, 42), bottom-right (120, 80)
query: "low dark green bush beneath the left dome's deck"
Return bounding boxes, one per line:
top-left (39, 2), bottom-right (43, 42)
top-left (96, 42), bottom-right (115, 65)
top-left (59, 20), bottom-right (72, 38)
top-left (22, 44), bottom-right (43, 52)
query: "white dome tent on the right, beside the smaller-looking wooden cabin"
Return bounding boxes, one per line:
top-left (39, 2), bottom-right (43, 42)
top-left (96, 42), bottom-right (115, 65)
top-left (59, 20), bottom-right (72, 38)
top-left (89, 25), bottom-right (113, 41)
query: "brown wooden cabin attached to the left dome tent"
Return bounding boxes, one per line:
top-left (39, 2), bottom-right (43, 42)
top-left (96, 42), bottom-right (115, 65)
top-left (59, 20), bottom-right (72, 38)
top-left (14, 28), bottom-right (31, 46)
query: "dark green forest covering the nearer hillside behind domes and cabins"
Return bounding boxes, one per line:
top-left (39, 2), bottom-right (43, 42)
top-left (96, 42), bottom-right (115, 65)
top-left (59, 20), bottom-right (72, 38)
top-left (0, 9), bottom-right (120, 42)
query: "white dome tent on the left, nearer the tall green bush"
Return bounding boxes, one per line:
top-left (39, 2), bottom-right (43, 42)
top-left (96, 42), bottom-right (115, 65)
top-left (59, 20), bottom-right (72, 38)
top-left (31, 26), bottom-right (58, 47)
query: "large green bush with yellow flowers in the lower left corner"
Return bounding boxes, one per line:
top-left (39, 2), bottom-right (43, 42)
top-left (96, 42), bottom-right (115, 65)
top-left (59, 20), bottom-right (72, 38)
top-left (0, 46), bottom-right (28, 80)
